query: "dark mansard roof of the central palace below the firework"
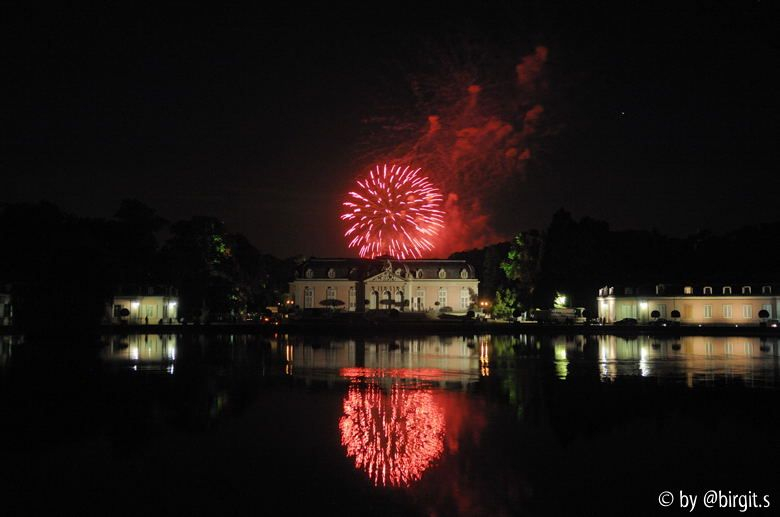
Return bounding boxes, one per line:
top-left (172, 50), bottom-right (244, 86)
top-left (295, 257), bottom-right (477, 280)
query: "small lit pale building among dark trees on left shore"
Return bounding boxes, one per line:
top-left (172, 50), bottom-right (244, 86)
top-left (106, 286), bottom-right (179, 325)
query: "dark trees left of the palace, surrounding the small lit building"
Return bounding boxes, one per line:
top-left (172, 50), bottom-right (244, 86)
top-left (0, 200), bottom-right (295, 329)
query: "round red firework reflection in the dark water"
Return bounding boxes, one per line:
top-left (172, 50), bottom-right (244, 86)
top-left (339, 369), bottom-right (445, 486)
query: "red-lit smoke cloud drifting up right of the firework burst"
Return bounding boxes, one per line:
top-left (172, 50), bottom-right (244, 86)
top-left (361, 46), bottom-right (548, 256)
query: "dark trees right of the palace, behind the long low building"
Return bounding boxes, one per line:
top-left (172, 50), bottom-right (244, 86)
top-left (452, 210), bottom-right (780, 314)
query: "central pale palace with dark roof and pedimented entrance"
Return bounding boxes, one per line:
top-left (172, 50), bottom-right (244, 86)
top-left (290, 257), bottom-right (479, 313)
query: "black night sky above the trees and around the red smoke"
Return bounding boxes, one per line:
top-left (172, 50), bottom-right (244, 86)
top-left (0, 0), bottom-right (780, 256)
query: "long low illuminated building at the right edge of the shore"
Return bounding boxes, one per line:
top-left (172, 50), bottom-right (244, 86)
top-left (598, 284), bottom-right (780, 325)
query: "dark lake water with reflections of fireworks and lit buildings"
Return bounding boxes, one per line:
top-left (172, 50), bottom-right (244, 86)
top-left (0, 335), bottom-right (780, 516)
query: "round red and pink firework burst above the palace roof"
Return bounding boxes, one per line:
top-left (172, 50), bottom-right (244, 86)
top-left (341, 164), bottom-right (444, 259)
